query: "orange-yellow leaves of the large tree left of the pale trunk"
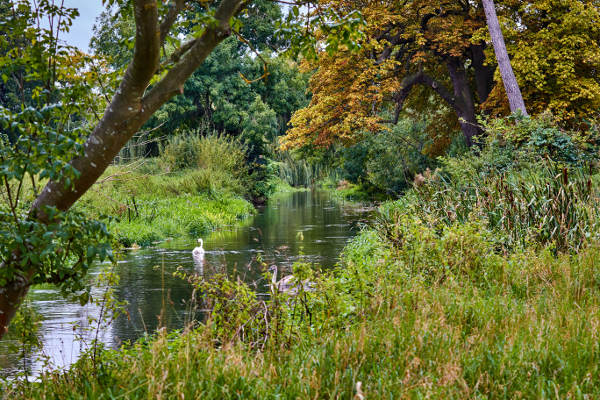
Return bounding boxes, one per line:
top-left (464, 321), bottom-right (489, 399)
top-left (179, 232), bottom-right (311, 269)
top-left (282, 0), bottom-right (482, 148)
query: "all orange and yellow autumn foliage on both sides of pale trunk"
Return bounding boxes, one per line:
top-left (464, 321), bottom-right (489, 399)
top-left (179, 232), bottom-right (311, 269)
top-left (283, 0), bottom-right (600, 153)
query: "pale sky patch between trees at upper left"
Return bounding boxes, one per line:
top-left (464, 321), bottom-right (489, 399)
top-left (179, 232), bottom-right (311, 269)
top-left (62, 0), bottom-right (104, 51)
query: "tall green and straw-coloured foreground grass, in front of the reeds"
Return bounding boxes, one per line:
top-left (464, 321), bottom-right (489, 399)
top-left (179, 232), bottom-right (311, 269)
top-left (2, 224), bottom-right (600, 399)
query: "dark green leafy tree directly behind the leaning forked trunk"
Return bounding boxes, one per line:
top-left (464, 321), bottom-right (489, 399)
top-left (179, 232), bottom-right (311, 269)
top-left (92, 0), bottom-right (307, 160)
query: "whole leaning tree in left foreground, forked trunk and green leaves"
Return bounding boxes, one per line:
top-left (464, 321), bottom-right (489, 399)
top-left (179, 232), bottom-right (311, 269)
top-left (0, 0), bottom-right (364, 338)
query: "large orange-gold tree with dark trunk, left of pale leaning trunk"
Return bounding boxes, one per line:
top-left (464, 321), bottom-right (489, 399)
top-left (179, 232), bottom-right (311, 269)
top-left (285, 0), bottom-right (494, 147)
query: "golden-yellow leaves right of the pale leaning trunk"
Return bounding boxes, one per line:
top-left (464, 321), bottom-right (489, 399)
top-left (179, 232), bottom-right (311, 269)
top-left (497, 0), bottom-right (600, 124)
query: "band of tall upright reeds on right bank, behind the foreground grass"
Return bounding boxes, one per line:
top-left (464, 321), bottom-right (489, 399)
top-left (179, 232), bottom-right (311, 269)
top-left (382, 163), bottom-right (600, 251)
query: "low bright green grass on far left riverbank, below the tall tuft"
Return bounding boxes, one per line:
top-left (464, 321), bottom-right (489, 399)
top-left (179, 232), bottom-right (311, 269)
top-left (77, 165), bottom-right (255, 247)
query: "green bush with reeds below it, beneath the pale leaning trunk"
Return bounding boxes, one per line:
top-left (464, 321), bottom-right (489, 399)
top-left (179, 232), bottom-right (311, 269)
top-left (383, 117), bottom-right (600, 252)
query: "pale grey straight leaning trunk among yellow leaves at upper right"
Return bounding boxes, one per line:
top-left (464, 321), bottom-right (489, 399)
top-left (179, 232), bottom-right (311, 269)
top-left (482, 0), bottom-right (527, 115)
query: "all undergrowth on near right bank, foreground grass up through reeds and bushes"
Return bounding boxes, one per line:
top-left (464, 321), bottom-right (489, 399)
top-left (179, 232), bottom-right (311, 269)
top-left (4, 115), bottom-right (600, 399)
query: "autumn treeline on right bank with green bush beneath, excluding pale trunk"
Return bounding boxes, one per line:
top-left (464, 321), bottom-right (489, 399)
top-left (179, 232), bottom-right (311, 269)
top-left (283, 0), bottom-right (600, 196)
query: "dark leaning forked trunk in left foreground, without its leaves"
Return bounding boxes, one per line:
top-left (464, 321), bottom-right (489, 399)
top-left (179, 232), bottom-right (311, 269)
top-left (0, 0), bottom-right (243, 339)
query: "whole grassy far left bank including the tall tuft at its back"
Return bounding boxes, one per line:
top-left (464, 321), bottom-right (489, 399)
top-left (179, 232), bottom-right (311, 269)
top-left (77, 134), bottom-right (257, 247)
